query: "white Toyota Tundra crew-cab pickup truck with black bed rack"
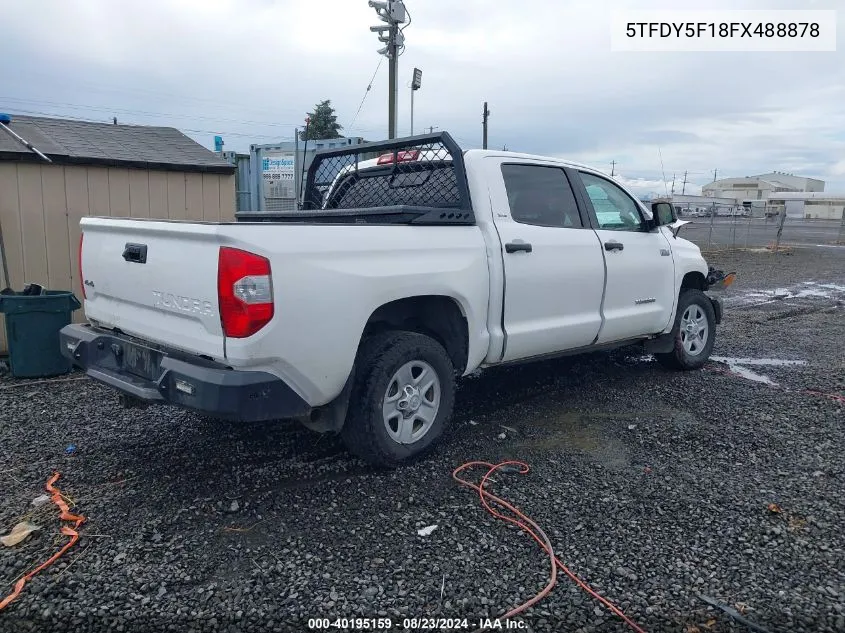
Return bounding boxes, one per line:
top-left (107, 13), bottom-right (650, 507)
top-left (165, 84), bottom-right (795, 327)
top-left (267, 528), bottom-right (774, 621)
top-left (61, 133), bottom-right (726, 467)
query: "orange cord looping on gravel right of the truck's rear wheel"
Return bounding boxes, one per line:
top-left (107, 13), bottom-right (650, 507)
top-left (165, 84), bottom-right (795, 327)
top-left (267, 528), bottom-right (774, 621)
top-left (452, 461), bottom-right (645, 633)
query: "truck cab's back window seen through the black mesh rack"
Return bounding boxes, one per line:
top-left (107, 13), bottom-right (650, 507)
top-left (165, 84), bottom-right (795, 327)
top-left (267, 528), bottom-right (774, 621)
top-left (325, 163), bottom-right (461, 209)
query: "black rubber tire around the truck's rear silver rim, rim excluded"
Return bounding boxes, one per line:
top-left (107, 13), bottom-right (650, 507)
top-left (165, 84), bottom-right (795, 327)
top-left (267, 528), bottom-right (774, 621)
top-left (341, 331), bottom-right (455, 468)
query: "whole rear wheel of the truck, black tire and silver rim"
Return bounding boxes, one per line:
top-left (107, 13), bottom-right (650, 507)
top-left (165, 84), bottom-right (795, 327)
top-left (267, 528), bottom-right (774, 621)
top-left (341, 332), bottom-right (455, 467)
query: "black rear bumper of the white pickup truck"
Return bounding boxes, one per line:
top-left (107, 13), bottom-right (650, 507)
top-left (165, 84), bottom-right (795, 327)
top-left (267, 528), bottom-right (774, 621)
top-left (59, 324), bottom-right (311, 422)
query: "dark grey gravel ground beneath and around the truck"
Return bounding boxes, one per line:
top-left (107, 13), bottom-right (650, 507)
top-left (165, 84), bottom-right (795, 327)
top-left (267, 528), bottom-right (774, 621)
top-left (0, 249), bottom-right (845, 633)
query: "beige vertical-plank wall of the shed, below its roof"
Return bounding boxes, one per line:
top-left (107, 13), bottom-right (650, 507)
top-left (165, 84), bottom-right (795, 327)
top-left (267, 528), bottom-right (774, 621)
top-left (0, 162), bottom-right (235, 353)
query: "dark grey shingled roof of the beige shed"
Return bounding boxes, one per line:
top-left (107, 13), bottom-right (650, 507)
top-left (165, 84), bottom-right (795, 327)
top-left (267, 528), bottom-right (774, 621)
top-left (0, 115), bottom-right (235, 173)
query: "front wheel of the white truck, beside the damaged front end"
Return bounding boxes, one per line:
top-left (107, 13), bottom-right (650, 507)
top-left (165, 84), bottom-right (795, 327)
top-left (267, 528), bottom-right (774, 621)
top-left (655, 289), bottom-right (716, 370)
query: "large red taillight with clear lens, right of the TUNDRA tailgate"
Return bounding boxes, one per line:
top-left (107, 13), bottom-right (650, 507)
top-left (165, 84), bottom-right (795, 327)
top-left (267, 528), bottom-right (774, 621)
top-left (217, 246), bottom-right (273, 338)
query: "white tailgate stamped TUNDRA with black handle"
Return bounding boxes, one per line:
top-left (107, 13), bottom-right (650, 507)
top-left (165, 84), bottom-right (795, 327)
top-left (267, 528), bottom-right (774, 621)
top-left (80, 218), bottom-right (224, 359)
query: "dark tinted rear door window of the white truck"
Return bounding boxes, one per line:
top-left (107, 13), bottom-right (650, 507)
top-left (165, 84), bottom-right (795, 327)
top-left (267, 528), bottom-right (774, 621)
top-left (502, 165), bottom-right (582, 229)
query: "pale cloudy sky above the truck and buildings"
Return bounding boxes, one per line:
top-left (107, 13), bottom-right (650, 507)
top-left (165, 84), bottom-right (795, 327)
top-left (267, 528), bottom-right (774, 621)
top-left (0, 0), bottom-right (845, 195)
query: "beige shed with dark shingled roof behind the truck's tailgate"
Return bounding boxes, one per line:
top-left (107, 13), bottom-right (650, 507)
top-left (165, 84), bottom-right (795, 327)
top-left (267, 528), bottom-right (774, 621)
top-left (0, 115), bottom-right (235, 353)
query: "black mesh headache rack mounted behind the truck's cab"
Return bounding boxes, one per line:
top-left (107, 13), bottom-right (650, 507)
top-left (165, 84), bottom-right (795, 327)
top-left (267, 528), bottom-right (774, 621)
top-left (237, 132), bottom-right (475, 225)
